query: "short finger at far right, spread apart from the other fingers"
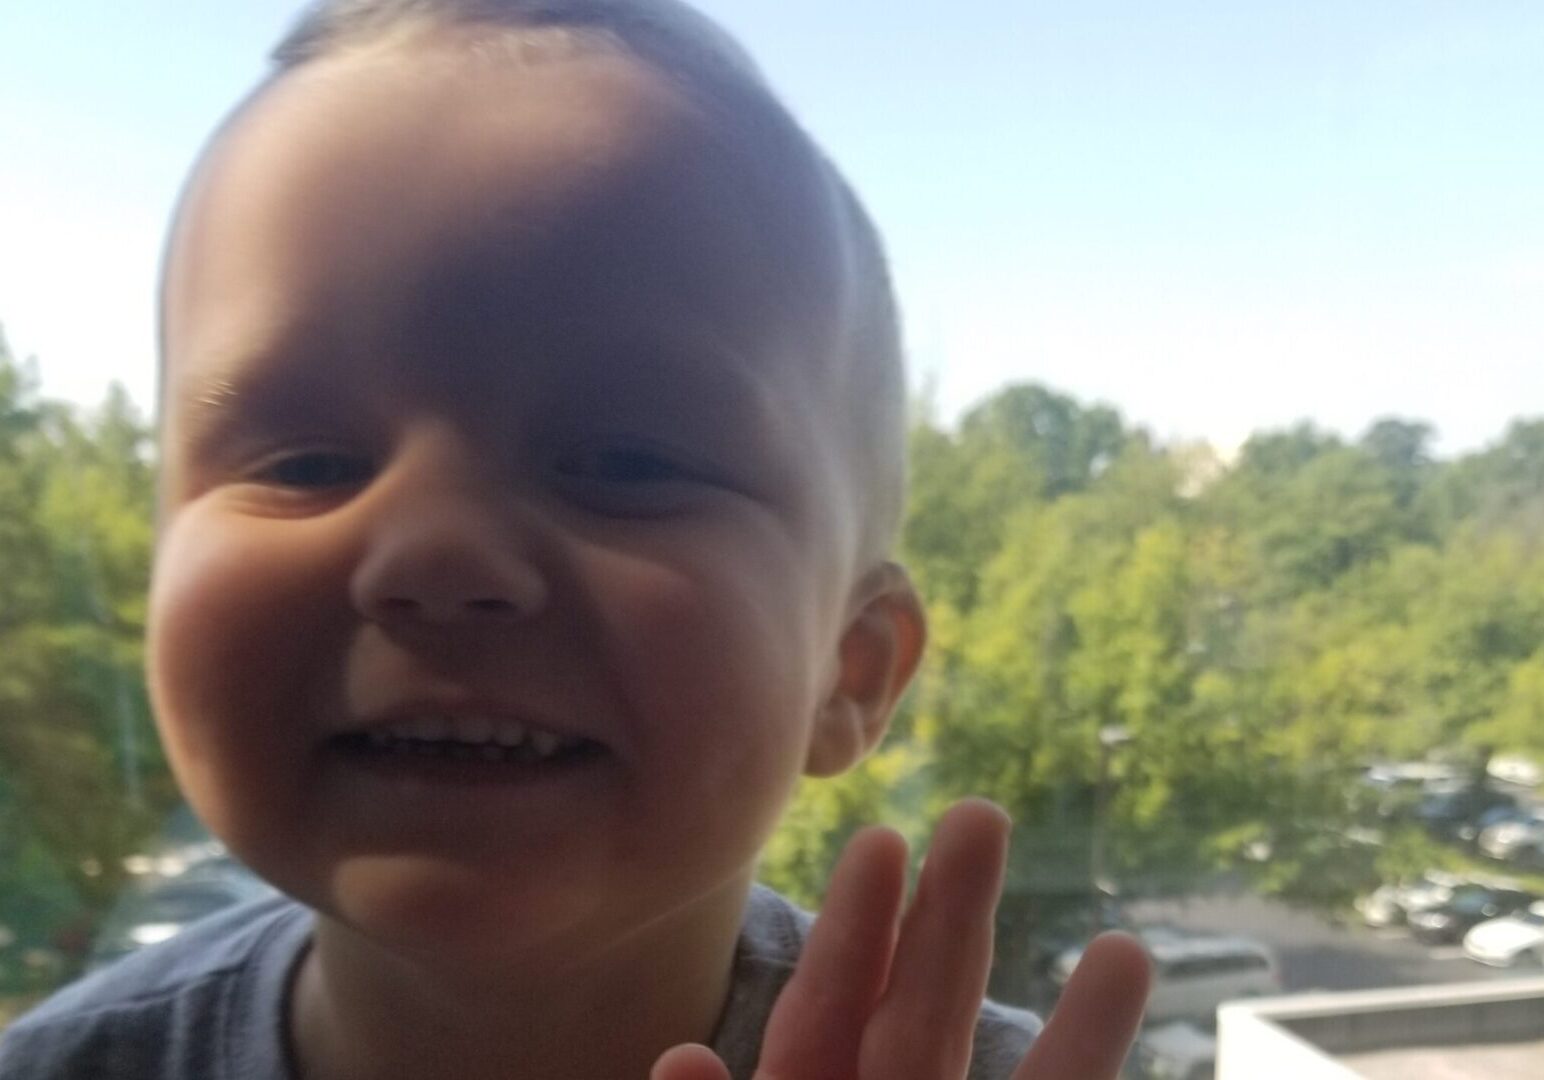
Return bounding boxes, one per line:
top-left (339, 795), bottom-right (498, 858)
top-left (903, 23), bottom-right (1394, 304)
top-left (1013, 933), bottom-right (1152, 1080)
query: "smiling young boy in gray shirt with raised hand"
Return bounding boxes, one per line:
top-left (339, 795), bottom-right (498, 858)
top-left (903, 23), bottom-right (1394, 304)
top-left (0, 0), bottom-right (1144, 1080)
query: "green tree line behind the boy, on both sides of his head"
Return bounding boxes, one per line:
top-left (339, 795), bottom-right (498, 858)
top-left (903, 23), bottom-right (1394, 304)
top-left (0, 318), bottom-right (1544, 989)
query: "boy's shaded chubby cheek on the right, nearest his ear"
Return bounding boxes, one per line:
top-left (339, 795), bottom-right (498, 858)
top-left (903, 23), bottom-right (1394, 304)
top-left (599, 543), bottom-right (823, 862)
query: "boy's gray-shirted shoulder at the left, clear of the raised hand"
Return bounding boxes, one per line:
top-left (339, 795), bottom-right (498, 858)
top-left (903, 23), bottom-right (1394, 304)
top-left (0, 896), bottom-right (310, 1080)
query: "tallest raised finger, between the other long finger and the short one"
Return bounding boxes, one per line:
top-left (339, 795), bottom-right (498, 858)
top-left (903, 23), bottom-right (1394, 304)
top-left (858, 799), bottom-right (1010, 1080)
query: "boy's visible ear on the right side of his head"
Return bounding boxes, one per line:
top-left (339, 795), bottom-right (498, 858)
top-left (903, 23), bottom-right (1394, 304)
top-left (804, 562), bottom-right (928, 776)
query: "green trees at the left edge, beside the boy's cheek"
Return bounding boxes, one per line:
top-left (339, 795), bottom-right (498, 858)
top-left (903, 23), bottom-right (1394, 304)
top-left (0, 332), bottom-right (173, 989)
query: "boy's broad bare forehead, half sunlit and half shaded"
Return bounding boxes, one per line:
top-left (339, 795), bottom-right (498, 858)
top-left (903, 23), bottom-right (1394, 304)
top-left (164, 42), bottom-right (846, 414)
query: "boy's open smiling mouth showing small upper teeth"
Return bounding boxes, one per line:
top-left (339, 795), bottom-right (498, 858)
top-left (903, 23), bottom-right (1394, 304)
top-left (327, 712), bottom-right (607, 777)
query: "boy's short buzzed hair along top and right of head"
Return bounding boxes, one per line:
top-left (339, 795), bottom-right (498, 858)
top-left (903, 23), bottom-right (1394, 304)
top-left (272, 0), bottom-right (906, 559)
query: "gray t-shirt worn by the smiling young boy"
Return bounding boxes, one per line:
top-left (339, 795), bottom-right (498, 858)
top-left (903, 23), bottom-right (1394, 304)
top-left (0, 885), bottom-right (1039, 1080)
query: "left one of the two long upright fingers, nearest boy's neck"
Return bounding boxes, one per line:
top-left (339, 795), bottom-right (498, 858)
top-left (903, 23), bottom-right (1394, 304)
top-left (757, 828), bottom-right (906, 1080)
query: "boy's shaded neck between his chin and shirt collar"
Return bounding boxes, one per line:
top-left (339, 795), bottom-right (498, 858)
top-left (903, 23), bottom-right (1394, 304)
top-left (289, 882), bottom-right (749, 1080)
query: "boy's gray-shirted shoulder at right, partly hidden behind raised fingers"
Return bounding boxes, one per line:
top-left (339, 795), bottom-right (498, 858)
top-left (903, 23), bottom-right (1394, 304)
top-left (720, 885), bottom-right (1041, 1080)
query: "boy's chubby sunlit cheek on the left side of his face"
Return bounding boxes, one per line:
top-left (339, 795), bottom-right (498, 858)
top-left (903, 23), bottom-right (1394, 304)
top-left (148, 508), bottom-right (347, 862)
